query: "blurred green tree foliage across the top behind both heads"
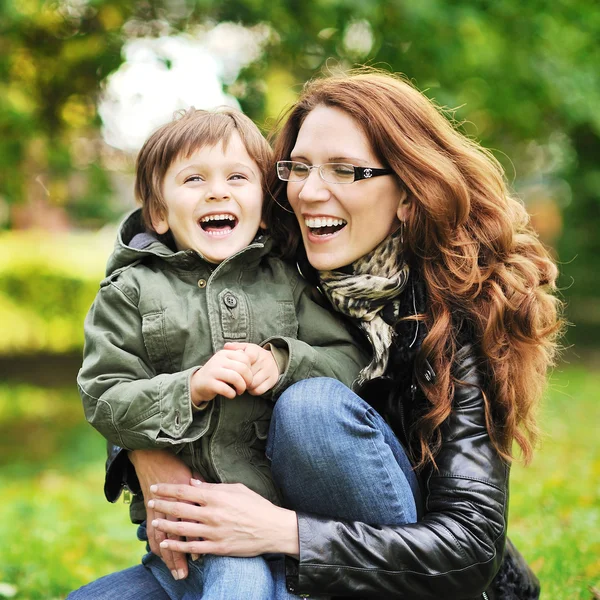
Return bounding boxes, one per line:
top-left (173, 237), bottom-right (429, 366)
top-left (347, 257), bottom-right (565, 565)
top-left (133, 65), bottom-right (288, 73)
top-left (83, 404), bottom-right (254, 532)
top-left (0, 0), bottom-right (600, 324)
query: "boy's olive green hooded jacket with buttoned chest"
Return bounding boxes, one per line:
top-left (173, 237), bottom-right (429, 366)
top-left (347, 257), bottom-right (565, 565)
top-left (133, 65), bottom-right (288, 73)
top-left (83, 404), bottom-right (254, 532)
top-left (77, 210), bottom-right (367, 501)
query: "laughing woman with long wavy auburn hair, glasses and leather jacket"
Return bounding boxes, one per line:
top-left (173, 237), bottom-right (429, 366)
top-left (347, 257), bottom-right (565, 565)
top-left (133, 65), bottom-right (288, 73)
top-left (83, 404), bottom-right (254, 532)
top-left (96, 72), bottom-right (560, 599)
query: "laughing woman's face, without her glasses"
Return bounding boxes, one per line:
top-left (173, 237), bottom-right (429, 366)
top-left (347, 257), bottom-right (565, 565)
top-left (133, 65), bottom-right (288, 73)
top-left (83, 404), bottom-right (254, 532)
top-left (287, 105), bottom-right (404, 270)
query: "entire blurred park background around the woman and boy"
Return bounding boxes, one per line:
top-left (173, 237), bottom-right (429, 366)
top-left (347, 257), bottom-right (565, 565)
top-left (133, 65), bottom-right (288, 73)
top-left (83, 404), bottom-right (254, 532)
top-left (0, 0), bottom-right (600, 600)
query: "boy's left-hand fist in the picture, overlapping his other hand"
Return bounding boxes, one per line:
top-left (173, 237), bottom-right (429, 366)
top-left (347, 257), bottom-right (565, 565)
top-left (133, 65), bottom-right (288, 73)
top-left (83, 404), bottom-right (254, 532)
top-left (191, 349), bottom-right (254, 406)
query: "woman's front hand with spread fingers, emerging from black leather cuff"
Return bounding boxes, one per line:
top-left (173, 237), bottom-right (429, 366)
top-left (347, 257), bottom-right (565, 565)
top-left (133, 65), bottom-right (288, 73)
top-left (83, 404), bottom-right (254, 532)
top-left (150, 479), bottom-right (299, 558)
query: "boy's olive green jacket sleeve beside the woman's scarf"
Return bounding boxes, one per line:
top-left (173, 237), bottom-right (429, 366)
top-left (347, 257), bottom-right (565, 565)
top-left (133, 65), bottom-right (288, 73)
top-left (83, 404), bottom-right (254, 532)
top-left (263, 277), bottom-right (369, 396)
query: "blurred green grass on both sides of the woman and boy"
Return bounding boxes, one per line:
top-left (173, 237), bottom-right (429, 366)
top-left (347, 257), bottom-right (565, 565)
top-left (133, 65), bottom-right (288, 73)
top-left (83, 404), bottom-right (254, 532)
top-left (0, 367), bottom-right (600, 600)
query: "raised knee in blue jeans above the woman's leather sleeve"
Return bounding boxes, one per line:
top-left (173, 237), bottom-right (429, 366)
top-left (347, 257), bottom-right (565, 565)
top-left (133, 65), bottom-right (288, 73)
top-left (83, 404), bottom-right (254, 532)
top-left (267, 377), bottom-right (420, 525)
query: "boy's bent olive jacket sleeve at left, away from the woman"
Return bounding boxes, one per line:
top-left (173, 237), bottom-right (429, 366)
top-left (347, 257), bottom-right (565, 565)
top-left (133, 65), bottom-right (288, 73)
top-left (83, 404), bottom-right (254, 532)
top-left (77, 282), bottom-right (212, 450)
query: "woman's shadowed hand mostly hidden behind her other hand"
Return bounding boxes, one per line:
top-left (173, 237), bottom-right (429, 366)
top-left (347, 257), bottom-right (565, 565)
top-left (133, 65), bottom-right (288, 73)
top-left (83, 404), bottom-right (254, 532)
top-left (129, 450), bottom-right (197, 579)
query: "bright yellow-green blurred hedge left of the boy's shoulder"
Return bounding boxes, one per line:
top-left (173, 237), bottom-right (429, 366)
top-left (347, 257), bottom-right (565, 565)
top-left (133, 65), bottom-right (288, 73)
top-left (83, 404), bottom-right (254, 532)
top-left (0, 231), bottom-right (114, 354)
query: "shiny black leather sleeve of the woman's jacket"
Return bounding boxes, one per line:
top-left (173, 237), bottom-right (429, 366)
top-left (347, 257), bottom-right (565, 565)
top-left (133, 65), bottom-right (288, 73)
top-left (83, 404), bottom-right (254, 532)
top-left (287, 346), bottom-right (509, 600)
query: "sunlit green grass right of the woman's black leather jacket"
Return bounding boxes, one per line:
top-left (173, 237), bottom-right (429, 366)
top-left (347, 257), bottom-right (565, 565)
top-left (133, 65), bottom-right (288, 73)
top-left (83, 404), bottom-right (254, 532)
top-left (509, 367), bottom-right (600, 600)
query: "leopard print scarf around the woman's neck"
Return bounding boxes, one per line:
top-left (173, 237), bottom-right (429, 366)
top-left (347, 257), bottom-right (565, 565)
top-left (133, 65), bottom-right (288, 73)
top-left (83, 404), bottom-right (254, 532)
top-left (319, 232), bottom-right (409, 385)
